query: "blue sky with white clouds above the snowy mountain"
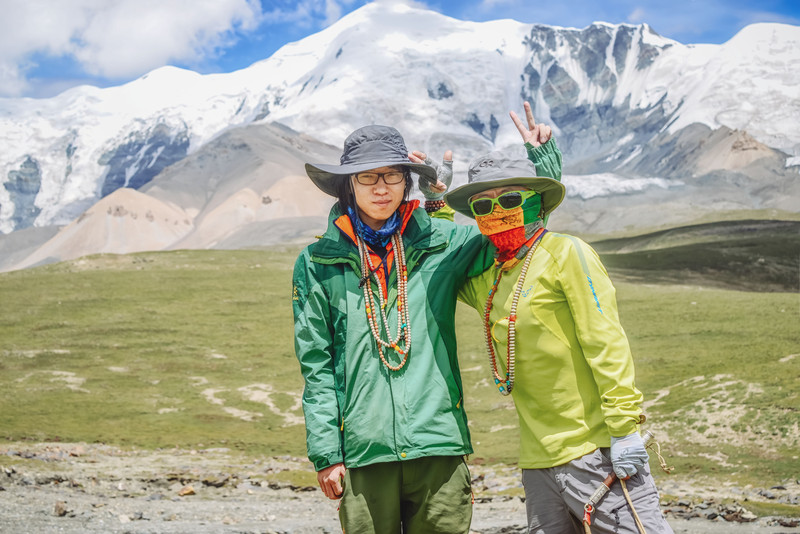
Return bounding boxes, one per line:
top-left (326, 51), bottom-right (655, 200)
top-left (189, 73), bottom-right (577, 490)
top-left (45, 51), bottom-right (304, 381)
top-left (0, 0), bottom-right (800, 98)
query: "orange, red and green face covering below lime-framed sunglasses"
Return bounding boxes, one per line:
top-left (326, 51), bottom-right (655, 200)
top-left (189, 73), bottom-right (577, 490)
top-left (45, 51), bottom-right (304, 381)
top-left (475, 195), bottom-right (542, 262)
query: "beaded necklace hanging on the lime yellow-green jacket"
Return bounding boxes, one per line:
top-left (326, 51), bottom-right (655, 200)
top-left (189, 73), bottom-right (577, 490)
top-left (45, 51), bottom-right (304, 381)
top-left (483, 228), bottom-right (547, 395)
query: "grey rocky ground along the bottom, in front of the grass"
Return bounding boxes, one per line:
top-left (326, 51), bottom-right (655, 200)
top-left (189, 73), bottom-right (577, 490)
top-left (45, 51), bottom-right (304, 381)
top-left (0, 443), bottom-right (800, 534)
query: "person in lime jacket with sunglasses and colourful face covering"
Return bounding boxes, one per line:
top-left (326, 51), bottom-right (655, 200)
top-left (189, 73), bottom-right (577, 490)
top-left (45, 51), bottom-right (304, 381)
top-left (445, 148), bottom-right (672, 534)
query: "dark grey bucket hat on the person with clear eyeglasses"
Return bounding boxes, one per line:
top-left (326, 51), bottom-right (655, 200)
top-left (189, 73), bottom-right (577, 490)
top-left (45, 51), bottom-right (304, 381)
top-left (306, 125), bottom-right (436, 197)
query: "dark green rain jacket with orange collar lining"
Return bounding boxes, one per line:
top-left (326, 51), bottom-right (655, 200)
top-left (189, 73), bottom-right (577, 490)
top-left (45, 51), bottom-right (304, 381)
top-left (292, 141), bottom-right (561, 471)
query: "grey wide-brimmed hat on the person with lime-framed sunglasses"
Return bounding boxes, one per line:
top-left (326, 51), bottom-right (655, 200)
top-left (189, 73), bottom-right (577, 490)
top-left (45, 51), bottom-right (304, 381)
top-left (444, 152), bottom-right (566, 219)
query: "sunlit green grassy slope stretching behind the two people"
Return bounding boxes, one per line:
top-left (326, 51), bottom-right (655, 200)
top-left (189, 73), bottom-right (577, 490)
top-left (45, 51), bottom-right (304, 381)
top-left (0, 224), bottom-right (800, 496)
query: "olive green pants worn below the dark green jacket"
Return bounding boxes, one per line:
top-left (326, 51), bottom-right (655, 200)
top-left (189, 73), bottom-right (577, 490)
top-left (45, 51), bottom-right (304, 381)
top-left (339, 456), bottom-right (472, 534)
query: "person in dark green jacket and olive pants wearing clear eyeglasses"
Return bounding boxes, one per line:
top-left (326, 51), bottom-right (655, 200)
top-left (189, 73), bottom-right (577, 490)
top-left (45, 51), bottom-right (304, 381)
top-left (292, 125), bottom-right (561, 534)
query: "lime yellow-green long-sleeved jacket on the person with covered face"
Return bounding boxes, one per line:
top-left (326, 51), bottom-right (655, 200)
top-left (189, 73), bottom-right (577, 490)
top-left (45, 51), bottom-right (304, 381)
top-left (459, 232), bottom-right (642, 469)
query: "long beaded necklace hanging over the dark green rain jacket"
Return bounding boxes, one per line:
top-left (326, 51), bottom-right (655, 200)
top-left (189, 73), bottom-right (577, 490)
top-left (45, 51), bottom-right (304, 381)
top-left (356, 232), bottom-right (411, 371)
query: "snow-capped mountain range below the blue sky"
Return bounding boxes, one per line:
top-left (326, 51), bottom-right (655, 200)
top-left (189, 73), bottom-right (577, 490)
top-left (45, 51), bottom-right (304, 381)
top-left (0, 3), bottom-right (800, 244)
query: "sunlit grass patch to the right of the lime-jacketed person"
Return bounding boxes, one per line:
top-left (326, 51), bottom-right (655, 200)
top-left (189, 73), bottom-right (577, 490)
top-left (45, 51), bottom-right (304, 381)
top-left (618, 284), bottom-right (800, 482)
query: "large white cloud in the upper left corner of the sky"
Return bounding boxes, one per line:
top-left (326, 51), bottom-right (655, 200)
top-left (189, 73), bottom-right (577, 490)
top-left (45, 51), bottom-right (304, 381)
top-left (0, 0), bottom-right (261, 95)
